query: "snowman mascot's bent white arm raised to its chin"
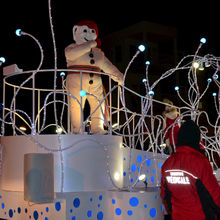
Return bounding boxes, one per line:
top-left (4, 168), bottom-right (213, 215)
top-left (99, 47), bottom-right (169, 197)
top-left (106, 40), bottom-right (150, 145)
top-left (65, 41), bottom-right (97, 61)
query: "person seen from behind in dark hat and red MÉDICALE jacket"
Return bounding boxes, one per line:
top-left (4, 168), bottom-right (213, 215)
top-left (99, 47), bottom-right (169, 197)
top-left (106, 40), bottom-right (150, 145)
top-left (161, 120), bottom-right (220, 220)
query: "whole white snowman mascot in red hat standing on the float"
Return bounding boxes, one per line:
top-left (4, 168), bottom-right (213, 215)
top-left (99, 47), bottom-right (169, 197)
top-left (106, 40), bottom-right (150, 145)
top-left (65, 20), bottom-right (123, 134)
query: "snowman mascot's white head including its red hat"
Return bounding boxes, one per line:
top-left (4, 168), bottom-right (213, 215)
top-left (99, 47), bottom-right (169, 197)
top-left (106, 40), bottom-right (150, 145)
top-left (73, 20), bottom-right (99, 46)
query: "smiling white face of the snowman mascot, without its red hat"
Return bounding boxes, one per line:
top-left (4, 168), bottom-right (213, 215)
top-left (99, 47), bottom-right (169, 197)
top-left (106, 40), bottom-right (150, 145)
top-left (73, 25), bottom-right (97, 44)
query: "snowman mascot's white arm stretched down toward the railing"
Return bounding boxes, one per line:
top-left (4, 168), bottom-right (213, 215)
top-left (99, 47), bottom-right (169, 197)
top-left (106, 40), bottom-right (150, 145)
top-left (102, 56), bottom-right (123, 84)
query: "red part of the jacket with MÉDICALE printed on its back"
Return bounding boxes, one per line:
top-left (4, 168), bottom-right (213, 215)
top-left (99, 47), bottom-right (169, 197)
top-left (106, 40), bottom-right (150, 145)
top-left (161, 146), bottom-right (220, 220)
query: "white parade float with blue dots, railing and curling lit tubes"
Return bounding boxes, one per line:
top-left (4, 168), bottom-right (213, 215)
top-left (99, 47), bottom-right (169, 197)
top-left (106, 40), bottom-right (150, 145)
top-left (0, 1), bottom-right (220, 220)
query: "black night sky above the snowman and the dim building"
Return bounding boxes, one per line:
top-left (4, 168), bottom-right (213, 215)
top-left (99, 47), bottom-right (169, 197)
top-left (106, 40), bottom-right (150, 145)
top-left (0, 0), bottom-right (220, 69)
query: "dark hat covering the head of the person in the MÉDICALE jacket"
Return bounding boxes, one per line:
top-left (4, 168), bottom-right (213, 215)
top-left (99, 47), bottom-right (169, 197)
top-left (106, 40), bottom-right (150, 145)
top-left (176, 120), bottom-right (201, 152)
